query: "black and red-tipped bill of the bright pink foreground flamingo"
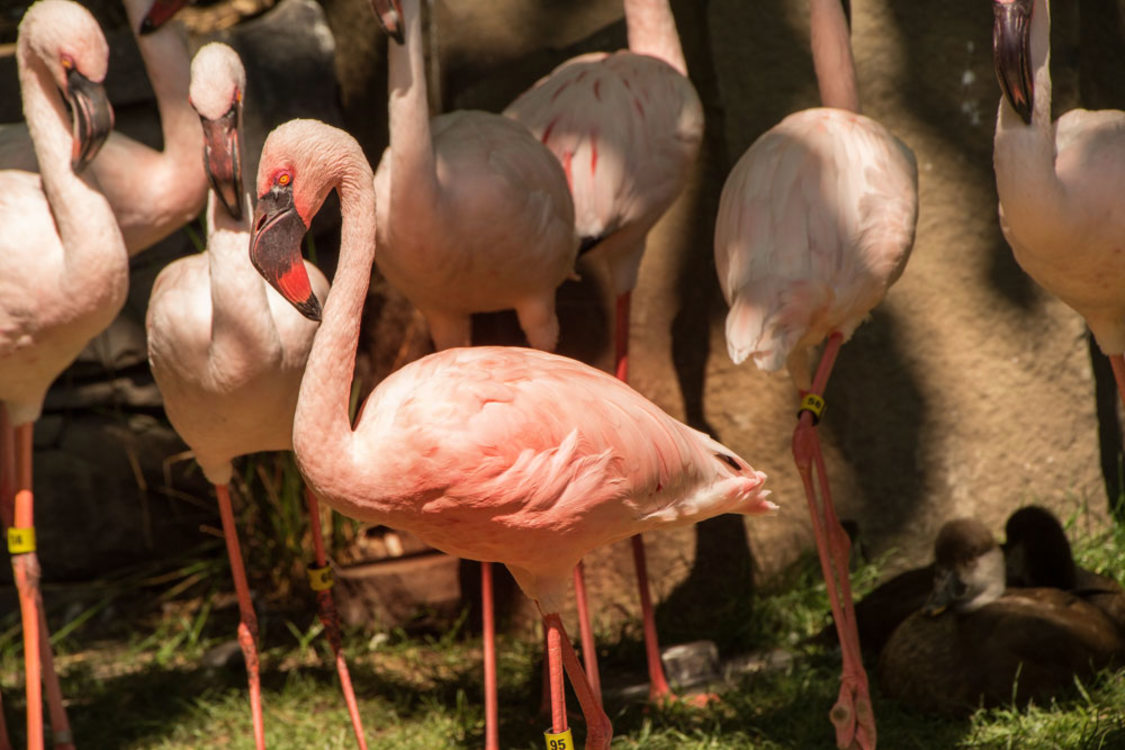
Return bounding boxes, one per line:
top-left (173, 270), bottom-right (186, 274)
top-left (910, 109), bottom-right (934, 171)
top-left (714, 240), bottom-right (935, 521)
top-left (250, 186), bottom-right (321, 320)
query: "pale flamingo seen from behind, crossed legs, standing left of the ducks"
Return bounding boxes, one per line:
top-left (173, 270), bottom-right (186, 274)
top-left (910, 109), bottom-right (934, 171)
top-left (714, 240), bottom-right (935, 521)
top-left (714, 0), bottom-right (918, 750)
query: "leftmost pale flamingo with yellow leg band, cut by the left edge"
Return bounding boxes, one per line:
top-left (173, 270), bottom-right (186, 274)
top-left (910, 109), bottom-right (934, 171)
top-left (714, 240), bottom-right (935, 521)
top-left (0, 0), bottom-right (128, 749)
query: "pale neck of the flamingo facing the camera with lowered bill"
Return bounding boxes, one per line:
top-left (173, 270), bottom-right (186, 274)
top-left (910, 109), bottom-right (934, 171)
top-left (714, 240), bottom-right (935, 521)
top-left (207, 191), bottom-right (281, 372)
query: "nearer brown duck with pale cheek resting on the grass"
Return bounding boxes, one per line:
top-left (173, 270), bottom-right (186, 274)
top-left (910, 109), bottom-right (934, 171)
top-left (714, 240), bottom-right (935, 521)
top-left (878, 518), bottom-right (1125, 714)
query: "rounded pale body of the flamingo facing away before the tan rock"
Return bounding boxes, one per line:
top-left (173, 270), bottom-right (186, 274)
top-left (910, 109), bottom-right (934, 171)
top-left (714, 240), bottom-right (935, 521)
top-left (714, 108), bottom-right (918, 387)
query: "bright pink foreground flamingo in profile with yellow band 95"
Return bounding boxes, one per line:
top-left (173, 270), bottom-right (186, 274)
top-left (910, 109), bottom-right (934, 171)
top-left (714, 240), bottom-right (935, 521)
top-left (250, 115), bottom-right (775, 750)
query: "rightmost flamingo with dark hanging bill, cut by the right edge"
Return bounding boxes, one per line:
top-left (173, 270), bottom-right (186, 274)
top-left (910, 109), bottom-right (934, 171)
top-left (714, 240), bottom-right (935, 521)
top-left (992, 0), bottom-right (1125, 399)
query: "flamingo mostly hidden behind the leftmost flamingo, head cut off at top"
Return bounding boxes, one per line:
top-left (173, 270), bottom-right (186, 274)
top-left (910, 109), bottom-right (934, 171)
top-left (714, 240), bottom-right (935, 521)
top-left (0, 0), bottom-right (207, 255)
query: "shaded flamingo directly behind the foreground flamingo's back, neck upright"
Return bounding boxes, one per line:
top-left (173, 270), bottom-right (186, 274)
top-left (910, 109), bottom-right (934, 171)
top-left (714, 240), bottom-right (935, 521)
top-left (371, 0), bottom-right (578, 750)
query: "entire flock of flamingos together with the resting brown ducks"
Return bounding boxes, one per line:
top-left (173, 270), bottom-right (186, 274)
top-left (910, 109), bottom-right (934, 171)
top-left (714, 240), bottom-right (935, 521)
top-left (0, 0), bottom-right (1125, 750)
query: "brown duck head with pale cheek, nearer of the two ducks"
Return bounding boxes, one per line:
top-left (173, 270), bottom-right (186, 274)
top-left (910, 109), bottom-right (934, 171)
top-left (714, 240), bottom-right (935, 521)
top-left (924, 518), bottom-right (1005, 615)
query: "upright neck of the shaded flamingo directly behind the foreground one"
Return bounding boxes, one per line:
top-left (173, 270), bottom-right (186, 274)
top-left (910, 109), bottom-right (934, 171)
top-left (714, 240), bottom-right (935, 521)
top-left (387, 0), bottom-right (438, 207)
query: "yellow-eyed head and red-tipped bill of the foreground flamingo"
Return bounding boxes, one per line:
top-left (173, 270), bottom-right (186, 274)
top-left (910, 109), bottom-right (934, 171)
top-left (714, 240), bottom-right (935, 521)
top-left (250, 120), bottom-right (346, 320)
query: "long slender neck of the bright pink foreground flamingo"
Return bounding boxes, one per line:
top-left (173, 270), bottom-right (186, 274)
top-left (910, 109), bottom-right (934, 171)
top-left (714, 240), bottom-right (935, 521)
top-left (293, 156), bottom-right (375, 483)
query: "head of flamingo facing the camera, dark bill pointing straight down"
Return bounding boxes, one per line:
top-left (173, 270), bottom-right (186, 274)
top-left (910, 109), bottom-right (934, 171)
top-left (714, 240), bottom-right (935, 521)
top-left (188, 42), bottom-right (246, 220)
